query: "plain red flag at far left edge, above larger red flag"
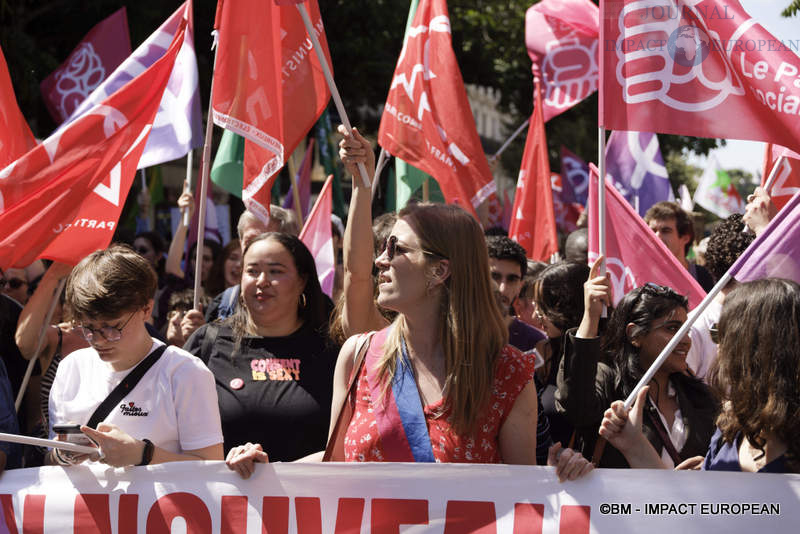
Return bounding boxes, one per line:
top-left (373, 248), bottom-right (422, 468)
top-left (0, 49), bottom-right (36, 168)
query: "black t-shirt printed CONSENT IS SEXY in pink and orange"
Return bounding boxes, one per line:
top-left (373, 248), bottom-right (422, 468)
top-left (184, 323), bottom-right (339, 462)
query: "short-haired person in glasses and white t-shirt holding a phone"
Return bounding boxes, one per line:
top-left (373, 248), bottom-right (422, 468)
top-left (47, 245), bottom-right (222, 467)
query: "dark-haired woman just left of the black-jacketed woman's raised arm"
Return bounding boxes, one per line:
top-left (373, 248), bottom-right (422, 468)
top-left (533, 262), bottom-right (589, 446)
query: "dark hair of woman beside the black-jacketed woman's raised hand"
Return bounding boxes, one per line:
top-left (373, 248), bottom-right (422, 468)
top-left (533, 261), bottom-right (589, 332)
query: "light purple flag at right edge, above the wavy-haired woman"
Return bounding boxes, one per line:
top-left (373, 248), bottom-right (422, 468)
top-left (730, 192), bottom-right (800, 283)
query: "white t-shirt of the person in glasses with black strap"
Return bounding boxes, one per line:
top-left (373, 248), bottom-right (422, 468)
top-left (49, 339), bottom-right (222, 453)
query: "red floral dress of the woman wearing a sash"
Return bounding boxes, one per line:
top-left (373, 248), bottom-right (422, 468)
top-left (344, 345), bottom-right (535, 464)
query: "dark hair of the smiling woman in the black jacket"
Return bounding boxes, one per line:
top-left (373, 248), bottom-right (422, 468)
top-left (603, 284), bottom-right (689, 397)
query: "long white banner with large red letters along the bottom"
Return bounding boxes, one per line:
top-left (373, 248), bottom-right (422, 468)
top-left (0, 462), bottom-right (800, 534)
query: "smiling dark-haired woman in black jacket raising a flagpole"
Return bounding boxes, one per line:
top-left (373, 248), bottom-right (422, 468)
top-left (556, 257), bottom-right (718, 467)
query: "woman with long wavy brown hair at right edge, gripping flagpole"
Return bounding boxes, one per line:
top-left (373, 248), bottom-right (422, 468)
top-left (601, 278), bottom-right (800, 473)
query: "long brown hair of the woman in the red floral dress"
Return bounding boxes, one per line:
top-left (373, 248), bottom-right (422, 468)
top-left (379, 204), bottom-right (508, 433)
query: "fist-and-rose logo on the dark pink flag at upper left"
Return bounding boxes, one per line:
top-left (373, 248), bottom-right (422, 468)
top-left (55, 43), bottom-right (106, 117)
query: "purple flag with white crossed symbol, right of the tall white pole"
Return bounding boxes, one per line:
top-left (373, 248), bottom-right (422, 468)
top-left (606, 131), bottom-right (675, 217)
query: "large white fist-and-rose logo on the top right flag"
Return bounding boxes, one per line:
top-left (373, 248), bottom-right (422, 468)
top-left (614, 1), bottom-right (752, 112)
